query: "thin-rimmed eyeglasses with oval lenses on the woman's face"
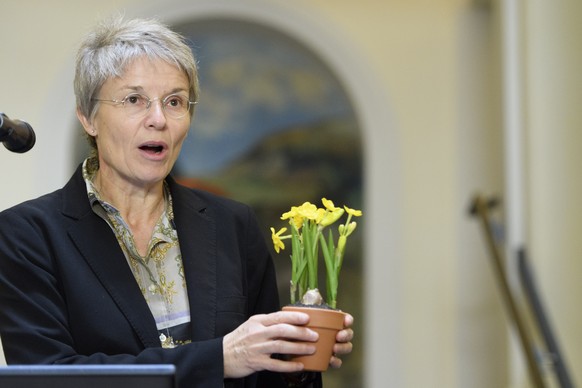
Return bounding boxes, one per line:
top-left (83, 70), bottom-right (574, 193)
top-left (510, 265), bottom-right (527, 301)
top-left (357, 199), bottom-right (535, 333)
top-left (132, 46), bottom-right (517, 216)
top-left (93, 93), bottom-right (198, 119)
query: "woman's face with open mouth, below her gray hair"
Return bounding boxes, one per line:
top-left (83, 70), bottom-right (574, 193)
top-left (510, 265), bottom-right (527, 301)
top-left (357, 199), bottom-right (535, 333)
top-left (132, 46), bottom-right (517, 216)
top-left (79, 58), bottom-right (190, 187)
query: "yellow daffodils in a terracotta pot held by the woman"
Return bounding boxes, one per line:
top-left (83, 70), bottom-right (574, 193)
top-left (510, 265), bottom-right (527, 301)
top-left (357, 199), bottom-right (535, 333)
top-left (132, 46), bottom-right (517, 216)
top-left (271, 198), bottom-right (362, 371)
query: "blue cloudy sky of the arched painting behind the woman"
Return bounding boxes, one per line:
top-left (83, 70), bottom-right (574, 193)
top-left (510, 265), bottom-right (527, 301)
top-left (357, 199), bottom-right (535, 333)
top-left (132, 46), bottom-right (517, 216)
top-left (176, 20), bottom-right (353, 177)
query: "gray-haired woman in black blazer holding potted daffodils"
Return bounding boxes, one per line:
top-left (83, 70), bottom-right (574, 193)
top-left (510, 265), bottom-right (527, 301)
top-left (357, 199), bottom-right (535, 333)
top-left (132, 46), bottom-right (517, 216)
top-left (0, 19), bottom-right (353, 388)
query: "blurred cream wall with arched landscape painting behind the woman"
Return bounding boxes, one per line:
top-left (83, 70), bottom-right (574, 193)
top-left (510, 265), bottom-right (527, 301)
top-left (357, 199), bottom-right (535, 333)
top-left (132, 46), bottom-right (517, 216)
top-left (0, 0), bottom-right (582, 388)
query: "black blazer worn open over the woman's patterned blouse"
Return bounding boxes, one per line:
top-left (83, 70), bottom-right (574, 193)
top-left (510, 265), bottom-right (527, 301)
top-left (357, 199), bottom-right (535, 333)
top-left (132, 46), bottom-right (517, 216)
top-left (0, 167), bottom-right (296, 388)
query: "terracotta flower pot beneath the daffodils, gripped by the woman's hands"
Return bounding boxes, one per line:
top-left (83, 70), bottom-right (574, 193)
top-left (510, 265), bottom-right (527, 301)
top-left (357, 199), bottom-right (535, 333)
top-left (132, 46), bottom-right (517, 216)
top-left (283, 306), bottom-right (346, 372)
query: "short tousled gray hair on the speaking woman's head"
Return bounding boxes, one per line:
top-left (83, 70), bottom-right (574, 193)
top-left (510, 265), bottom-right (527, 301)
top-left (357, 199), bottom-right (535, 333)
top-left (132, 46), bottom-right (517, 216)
top-left (74, 16), bottom-right (199, 146)
